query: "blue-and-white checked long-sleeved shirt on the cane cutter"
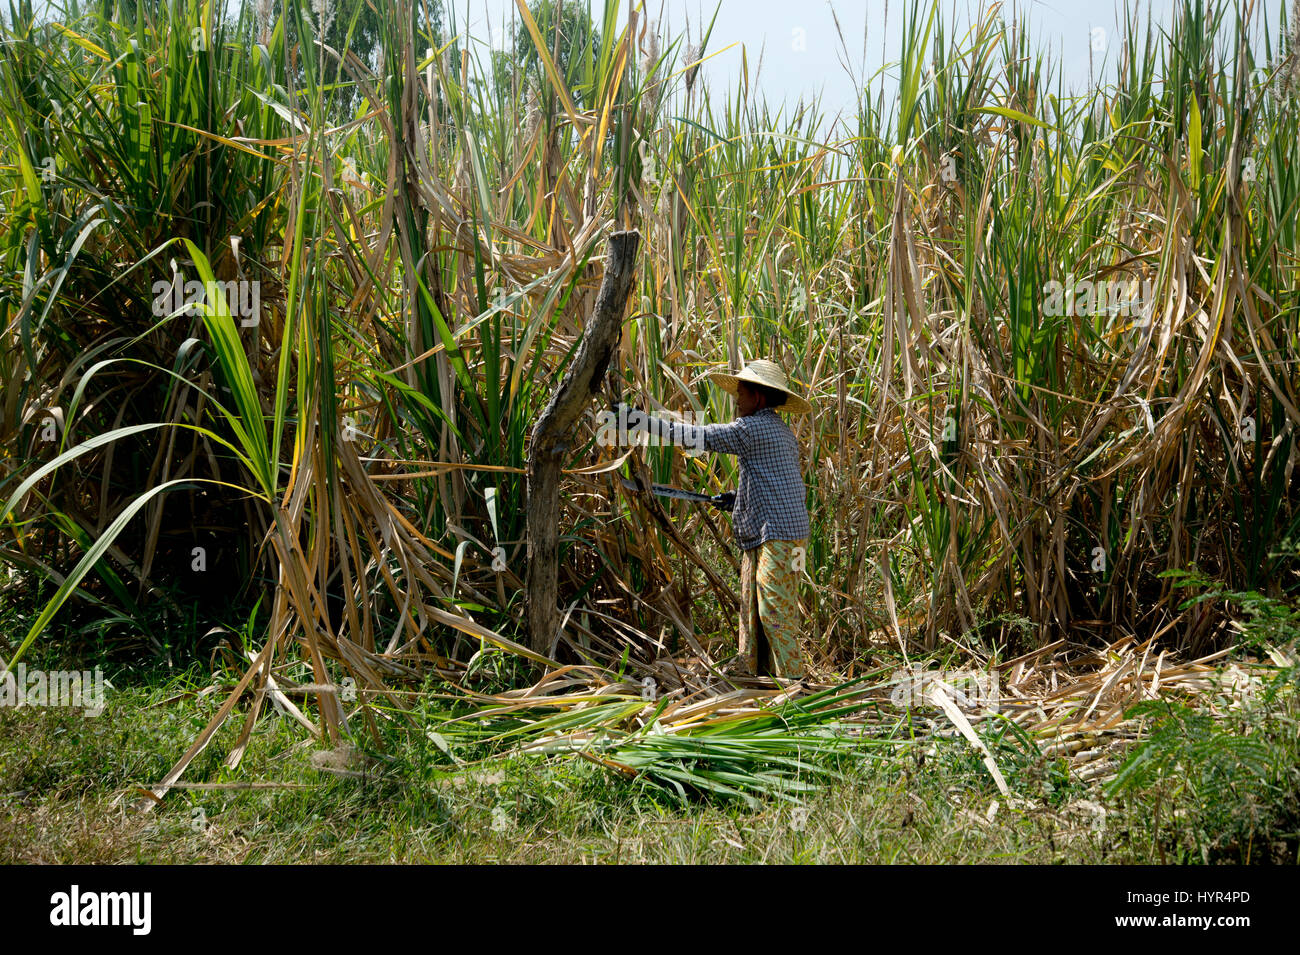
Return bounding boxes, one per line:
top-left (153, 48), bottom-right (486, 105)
top-left (637, 408), bottom-right (809, 551)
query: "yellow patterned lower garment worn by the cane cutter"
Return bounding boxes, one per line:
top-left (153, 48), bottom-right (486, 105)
top-left (740, 539), bottom-right (807, 680)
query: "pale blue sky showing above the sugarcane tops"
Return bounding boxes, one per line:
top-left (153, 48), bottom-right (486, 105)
top-left (449, 0), bottom-right (1281, 127)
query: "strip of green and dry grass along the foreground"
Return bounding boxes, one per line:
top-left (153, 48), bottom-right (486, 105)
top-left (0, 587), bottom-right (1300, 864)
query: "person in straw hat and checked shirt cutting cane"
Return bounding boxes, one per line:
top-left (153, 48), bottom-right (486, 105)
top-left (619, 359), bottom-right (813, 680)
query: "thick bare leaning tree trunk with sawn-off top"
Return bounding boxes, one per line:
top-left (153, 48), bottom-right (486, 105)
top-left (527, 231), bottom-right (641, 654)
